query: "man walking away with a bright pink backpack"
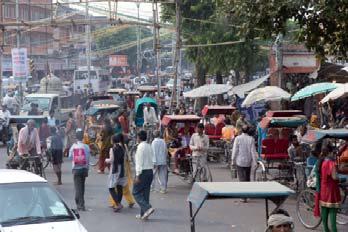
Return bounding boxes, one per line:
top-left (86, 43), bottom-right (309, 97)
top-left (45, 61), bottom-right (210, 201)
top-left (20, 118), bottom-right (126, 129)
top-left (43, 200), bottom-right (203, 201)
top-left (69, 129), bottom-right (90, 211)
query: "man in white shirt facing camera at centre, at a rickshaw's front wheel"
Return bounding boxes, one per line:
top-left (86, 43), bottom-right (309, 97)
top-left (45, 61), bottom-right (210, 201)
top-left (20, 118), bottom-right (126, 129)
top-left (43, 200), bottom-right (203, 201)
top-left (190, 123), bottom-right (209, 181)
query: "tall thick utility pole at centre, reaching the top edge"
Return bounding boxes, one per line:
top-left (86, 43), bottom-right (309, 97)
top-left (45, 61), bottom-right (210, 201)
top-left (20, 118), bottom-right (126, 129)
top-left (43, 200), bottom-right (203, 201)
top-left (170, 0), bottom-right (181, 112)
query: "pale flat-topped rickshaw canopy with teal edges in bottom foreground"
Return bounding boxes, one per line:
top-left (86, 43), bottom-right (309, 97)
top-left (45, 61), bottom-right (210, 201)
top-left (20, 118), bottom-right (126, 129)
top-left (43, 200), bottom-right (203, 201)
top-left (188, 181), bottom-right (295, 232)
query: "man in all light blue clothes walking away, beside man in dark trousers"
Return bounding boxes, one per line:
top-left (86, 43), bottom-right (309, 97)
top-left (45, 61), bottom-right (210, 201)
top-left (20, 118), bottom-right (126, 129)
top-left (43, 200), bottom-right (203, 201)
top-left (151, 130), bottom-right (168, 194)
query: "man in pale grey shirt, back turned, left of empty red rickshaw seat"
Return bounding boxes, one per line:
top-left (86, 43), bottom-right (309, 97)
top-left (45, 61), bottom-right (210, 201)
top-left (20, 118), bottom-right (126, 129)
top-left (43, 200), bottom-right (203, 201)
top-left (232, 125), bottom-right (257, 202)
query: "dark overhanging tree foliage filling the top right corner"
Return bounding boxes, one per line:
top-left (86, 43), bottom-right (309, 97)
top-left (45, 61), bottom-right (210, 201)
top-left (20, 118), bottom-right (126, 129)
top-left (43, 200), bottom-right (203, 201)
top-left (219, 0), bottom-right (348, 59)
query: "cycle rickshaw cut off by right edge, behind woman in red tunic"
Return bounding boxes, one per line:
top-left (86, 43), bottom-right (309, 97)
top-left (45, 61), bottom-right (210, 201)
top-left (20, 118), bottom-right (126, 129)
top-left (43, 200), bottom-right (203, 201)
top-left (296, 129), bottom-right (348, 229)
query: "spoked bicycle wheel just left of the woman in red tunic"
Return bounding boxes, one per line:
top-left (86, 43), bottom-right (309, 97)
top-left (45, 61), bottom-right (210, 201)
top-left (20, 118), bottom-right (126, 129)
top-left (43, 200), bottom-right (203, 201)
top-left (296, 189), bottom-right (321, 229)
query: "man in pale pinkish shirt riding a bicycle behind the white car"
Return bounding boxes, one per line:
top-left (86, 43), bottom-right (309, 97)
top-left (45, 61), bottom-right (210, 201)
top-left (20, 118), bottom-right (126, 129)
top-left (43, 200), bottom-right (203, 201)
top-left (17, 119), bottom-right (41, 170)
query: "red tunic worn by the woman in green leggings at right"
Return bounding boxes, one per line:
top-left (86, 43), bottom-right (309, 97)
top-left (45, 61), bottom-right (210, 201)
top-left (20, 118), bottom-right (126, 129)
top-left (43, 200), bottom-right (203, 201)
top-left (320, 159), bottom-right (341, 208)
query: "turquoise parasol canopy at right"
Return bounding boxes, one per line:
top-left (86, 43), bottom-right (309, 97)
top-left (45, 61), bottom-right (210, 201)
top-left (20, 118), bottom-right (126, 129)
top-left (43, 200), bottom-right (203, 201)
top-left (291, 82), bottom-right (341, 101)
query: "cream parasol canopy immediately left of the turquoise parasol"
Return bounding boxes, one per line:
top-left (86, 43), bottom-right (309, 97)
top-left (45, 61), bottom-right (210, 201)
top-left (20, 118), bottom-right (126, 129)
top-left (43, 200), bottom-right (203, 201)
top-left (242, 86), bottom-right (291, 107)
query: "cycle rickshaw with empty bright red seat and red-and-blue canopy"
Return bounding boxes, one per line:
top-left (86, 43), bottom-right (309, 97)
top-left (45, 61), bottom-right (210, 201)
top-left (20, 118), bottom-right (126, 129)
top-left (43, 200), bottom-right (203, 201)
top-left (253, 111), bottom-right (307, 188)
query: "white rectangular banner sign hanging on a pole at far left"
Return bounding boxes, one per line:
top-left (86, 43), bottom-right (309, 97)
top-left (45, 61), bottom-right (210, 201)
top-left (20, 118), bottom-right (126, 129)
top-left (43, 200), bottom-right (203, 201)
top-left (11, 48), bottom-right (28, 81)
